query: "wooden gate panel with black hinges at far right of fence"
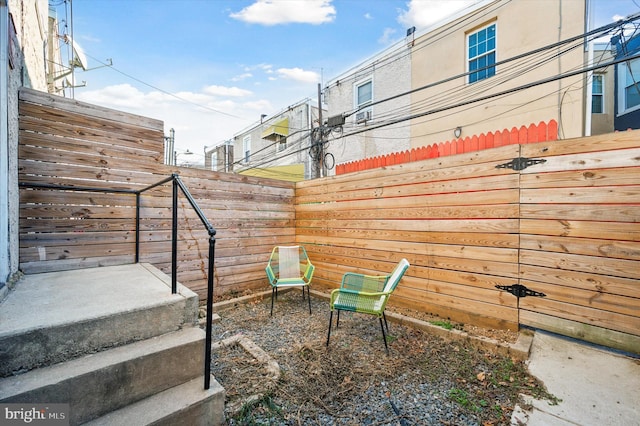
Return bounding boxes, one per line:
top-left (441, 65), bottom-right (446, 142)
top-left (520, 131), bottom-right (640, 352)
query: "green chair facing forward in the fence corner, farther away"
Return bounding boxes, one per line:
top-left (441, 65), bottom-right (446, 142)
top-left (265, 246), bottom-right (315, 315)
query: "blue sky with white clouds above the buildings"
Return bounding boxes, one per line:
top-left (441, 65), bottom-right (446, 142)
top-left (52, 0), bottom-right (640, 162)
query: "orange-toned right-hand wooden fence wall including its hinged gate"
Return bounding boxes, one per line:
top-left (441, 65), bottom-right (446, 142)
top-left (296, 131), bottom-right (640, 353)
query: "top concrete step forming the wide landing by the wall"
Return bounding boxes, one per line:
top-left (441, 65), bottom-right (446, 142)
top-left (0, 263), bottom-right (198, 377)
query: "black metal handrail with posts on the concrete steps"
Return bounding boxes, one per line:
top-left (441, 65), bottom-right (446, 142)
top-left (19, 173), bottom-right (216, 389)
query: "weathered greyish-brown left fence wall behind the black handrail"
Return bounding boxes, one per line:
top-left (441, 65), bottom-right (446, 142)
top-left (19, 89), bottom-right (295, 296)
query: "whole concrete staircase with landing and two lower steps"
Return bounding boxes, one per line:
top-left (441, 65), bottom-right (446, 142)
top-left (0, 264), bottom-right (224, 425)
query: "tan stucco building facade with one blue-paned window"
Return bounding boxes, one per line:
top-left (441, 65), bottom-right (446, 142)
top-left (411, 0), bottom-right (586, 147)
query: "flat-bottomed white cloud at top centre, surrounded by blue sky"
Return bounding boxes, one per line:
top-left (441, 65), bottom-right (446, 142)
top-left (229, 0), bottom-right (336, 25)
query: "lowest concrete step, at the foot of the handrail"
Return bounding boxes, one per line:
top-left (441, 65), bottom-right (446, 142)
top-left (85, 376), bottom-right (225, 426)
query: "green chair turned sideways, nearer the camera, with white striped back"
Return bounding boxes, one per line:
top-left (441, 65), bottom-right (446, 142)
top-left (327, 259), bottom-right (409, 354)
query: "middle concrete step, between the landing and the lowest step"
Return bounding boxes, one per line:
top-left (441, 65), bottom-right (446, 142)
top-left (0, 327), bottom-right (205, 424)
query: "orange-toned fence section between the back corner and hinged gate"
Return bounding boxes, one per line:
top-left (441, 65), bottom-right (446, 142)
top-left (296, 145), bottom-right (520, 329)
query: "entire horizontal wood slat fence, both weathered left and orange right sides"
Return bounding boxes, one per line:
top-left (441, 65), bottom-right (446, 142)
top-left (19, 90), bottom-right (640, 353)
